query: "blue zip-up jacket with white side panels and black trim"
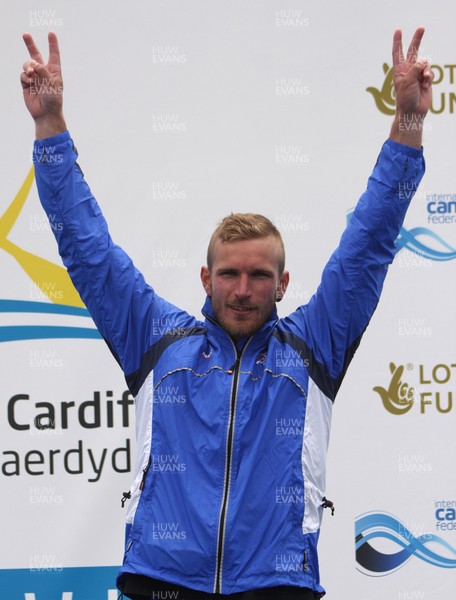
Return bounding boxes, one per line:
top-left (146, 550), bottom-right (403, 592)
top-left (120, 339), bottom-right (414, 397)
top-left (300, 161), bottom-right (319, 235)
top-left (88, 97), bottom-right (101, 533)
top-left (35, 132), bottom-right (424, 594)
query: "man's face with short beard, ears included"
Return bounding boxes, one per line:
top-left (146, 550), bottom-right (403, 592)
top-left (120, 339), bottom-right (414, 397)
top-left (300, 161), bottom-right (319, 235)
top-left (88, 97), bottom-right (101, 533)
top-left (201, 235), bottom-right (289, 340)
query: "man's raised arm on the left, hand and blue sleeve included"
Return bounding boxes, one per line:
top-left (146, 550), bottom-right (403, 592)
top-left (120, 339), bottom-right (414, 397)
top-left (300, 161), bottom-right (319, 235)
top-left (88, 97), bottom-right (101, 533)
top-left (21, 33), bottom-right (196, 393)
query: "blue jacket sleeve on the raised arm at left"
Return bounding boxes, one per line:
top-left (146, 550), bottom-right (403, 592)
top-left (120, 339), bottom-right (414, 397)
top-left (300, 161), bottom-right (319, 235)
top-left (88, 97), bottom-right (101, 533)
top-left (34, 132), bottom-right (196, 381)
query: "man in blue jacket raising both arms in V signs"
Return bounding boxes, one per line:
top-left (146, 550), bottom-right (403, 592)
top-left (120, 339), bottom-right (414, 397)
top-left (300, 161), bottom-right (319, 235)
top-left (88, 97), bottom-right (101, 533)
top-left (21, 28), bottom-right (432, 600)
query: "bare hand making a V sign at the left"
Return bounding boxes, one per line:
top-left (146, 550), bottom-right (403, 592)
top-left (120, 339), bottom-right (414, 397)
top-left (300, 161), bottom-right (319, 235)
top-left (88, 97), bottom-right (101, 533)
top-left (21, 32), bottom-right (66, 140)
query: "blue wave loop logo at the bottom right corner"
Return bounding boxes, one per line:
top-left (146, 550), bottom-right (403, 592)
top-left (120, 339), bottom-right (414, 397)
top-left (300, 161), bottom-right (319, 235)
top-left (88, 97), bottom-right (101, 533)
top-left (355, 512), bottom-right (456, 577)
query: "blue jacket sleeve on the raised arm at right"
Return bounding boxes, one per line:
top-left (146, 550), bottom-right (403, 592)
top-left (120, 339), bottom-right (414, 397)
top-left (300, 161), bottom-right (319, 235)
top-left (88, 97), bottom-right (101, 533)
top-left (284, 140), bottom-right (425, 399)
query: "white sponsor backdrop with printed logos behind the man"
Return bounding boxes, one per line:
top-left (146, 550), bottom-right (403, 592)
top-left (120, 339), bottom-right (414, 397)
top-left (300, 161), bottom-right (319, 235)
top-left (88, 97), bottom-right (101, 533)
top-left (0, 0), bottom-right (456, 600)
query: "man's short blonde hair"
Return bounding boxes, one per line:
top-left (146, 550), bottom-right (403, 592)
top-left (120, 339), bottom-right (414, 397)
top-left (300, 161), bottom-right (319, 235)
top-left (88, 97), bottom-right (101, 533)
top-left (207, 213), bottom-right (285, 274)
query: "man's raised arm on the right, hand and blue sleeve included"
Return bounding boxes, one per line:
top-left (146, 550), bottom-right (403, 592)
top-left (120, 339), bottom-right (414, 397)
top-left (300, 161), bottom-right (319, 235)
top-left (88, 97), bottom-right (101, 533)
top-left (282, 29), bottom-right (432, 399)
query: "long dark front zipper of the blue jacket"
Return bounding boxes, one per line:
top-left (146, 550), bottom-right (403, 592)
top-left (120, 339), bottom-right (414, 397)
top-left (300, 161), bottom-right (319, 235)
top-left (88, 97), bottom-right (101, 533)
top-left (214, 339), bottom-right (250, 594)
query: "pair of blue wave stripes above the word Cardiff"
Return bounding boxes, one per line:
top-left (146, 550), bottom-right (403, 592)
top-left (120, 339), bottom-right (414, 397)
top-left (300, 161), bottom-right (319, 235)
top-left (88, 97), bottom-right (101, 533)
top-left (0, 300), bottom-right (101, 343)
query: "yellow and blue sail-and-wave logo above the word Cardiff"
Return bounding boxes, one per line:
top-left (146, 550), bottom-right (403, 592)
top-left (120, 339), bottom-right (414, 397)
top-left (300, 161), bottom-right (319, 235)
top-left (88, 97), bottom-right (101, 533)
top-left (0, 167), bottom-right (101, 342)
